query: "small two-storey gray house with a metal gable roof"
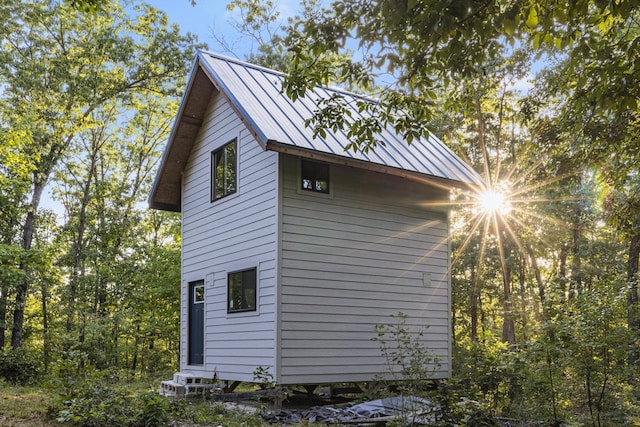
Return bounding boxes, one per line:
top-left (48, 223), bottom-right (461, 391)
top-left (149, 51), bottom-right (481, 384)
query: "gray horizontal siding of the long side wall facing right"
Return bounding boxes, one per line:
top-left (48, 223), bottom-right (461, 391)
top-left (279, 156), bottom-right (451, 384)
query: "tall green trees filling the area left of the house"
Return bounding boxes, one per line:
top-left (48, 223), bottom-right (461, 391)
top-left (0, 1), bottom-right (195, 371)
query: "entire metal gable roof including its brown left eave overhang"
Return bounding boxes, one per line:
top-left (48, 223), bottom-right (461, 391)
top-left (149, 51), bottom-right (485, 211)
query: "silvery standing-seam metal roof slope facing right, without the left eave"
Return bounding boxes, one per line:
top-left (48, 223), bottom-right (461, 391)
top-left (198, 51), bottom-right (483, 186)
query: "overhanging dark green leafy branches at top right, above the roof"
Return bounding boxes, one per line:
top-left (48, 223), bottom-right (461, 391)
top-left (284, 0), bottom-right (640, 166)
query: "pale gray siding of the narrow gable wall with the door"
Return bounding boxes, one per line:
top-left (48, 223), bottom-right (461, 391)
top-left (181, 94), bottom-right (278, 381)
